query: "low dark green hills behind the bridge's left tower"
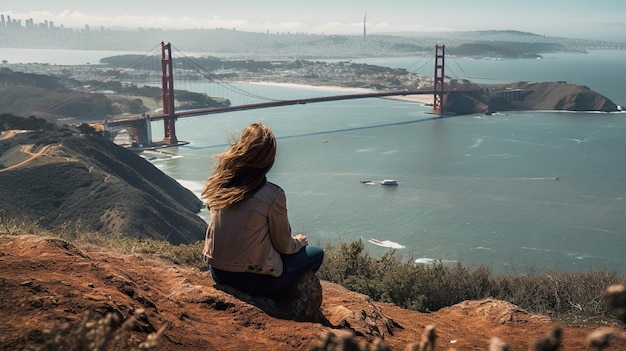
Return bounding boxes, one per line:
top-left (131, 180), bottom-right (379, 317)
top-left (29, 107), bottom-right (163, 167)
top-left (0, 66), bottom-right (230, 122)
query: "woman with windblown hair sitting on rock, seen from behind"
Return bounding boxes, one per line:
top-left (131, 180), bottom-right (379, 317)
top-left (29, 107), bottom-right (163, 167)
top-left (202, 123), bottom-right (324, 296)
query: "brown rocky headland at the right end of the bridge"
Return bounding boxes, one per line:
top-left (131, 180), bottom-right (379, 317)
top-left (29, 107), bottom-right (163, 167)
top-left (444, 82), bottom-right (621, 115)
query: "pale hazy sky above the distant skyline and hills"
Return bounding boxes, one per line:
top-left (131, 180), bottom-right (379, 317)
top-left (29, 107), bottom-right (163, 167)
top-left (0, 0), bottom-right (626, 42)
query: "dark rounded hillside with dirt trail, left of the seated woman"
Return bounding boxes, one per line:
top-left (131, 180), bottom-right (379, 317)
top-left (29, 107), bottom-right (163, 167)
top-left (0, 115), bottom-right (206, 244)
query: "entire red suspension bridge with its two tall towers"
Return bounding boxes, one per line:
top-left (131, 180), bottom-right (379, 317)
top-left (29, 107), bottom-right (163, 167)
top-left (40, 42), bottom-right (476, 148)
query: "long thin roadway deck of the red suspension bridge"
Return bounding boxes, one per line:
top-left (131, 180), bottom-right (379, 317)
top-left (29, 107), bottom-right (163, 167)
top-left (103, 90), bottom-right (438, 125)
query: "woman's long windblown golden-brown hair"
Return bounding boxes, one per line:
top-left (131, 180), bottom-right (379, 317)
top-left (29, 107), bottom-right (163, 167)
top-left (201, 123), bottom-right (276, 209)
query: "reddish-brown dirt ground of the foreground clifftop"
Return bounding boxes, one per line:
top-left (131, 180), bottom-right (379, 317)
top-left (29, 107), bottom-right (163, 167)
top-left (0, 235), bottom-right (626, 351)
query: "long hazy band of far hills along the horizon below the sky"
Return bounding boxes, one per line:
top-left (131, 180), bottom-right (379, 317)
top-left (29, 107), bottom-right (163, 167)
top-left (0, 28), bottom-right (626, 62)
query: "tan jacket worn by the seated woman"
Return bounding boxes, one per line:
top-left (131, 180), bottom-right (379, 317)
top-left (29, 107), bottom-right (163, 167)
top-left (203, 182), bottom-right (302, 277)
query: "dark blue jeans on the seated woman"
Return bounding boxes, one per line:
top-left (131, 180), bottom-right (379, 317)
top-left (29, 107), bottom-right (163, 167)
top-left (211, 245), bottom-right (324, 296)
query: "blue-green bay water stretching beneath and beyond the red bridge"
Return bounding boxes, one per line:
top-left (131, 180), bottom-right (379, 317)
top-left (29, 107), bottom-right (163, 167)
top-left (4, 46), bottom-right (626, 273)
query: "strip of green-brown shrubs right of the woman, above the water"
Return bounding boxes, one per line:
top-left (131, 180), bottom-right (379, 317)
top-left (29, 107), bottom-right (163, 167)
top-left (318, 240), bottom-right (626, 323)
